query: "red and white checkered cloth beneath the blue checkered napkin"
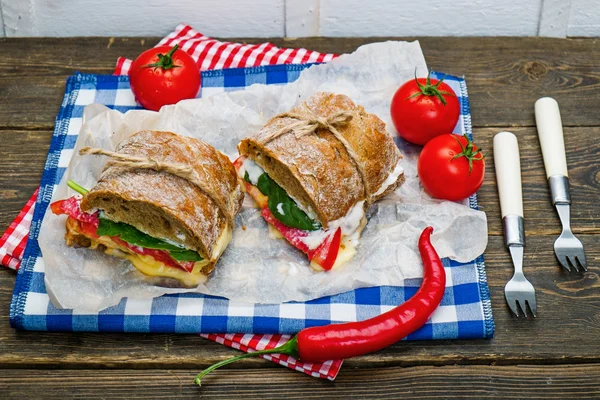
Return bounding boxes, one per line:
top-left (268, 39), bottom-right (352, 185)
top-left (0, 24), bottom-right (342, 380)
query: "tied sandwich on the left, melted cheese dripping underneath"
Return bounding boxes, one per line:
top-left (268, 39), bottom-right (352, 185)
top-left (51, 131), bottom-right (243, 287)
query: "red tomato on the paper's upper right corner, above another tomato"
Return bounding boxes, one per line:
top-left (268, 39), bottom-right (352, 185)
top-left (391, 71), bottom-right (460, 145)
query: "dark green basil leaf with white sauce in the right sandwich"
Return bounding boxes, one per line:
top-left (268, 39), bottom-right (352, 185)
top-left (256, 174), bottom-right (321, 231)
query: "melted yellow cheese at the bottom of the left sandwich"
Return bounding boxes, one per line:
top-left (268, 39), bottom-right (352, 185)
top-left (84, 228), bottom-right (232, 287)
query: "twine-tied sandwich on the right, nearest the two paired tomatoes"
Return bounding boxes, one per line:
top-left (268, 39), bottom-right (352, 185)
top-left (234, 93), bottom-right (404, 270)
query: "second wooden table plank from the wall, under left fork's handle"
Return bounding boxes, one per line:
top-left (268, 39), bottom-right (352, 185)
top-left (0, 127), bottom-right (600, 235)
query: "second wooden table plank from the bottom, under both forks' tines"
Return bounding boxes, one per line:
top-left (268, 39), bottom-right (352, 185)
top-left (0, 235), bottom-right (600, 368)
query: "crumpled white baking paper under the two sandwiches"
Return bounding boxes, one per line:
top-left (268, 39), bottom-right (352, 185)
top-left (39, 42), bottom-right (487, 311)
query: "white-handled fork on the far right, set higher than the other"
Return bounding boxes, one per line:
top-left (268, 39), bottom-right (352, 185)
top-left (535, 97), bottom-right (587, 272)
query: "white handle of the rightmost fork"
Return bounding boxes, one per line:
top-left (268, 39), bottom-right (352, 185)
top-left (535, 97), bottom-right (569, 178)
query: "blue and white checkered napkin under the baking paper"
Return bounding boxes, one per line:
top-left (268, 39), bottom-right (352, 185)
top-left (10, 65), bottom-right (494, 340)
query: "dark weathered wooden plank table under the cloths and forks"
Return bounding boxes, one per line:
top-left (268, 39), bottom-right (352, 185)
top-left (0, 38), bottom-right (600, 399)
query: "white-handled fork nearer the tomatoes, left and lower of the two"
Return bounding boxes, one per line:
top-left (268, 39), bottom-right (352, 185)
top-left (494, 132), bottom-right (536, 317)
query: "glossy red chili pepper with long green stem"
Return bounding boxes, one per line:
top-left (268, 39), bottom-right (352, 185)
top-left (195, 227), bottom-right (446, 385)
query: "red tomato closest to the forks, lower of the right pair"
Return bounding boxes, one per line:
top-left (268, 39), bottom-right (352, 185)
top-left (417, 133), bottom-right (485, 201)
